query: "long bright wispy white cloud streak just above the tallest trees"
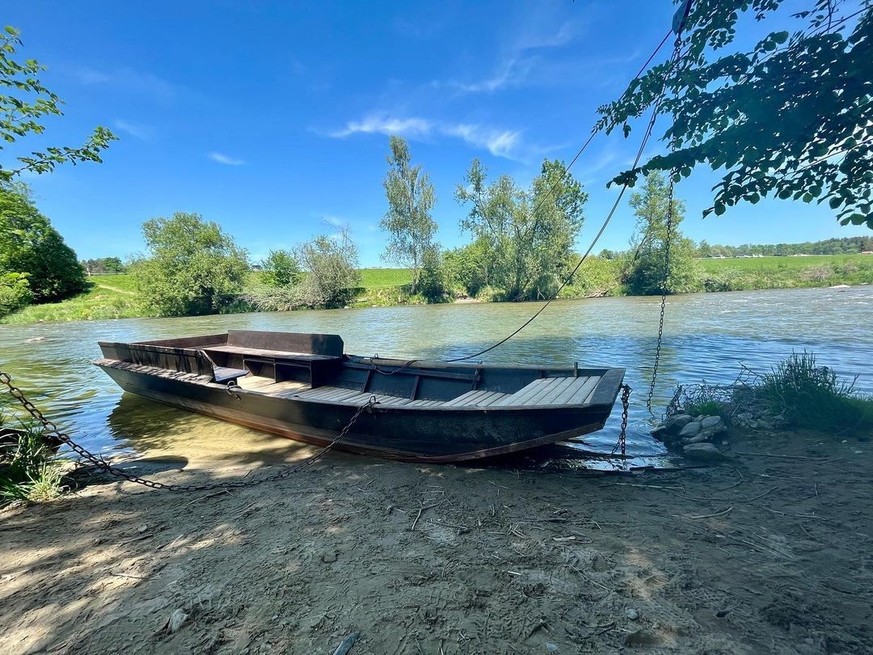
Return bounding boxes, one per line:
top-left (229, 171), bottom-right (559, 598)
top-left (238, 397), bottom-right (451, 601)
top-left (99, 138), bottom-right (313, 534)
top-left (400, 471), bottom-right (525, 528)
top-left (329, 112), bottom-right (522, 159)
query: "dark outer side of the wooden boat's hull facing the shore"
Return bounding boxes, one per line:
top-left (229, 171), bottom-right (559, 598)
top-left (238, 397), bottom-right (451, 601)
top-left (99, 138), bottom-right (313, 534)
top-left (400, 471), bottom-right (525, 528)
top-left (95, 359), bottom-right (621, 462)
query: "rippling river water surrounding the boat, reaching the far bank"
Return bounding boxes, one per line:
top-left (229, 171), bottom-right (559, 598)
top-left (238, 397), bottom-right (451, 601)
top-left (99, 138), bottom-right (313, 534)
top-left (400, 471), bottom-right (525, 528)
top-left (0, 286), bottom-right (873, 462)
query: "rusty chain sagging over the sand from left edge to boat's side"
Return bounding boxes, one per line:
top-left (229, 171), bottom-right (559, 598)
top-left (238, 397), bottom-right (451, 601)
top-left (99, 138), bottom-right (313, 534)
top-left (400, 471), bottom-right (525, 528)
top-left (0, 371), bottom-right (378, 492)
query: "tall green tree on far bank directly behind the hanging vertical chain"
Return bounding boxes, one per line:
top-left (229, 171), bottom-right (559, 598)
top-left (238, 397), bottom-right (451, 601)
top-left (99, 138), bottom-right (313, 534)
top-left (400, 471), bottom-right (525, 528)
top-left (622, 172), bottom-right (700, 296)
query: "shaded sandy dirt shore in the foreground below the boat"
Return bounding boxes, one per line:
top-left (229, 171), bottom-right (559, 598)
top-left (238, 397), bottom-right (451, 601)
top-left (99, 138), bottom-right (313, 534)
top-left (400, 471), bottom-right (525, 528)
top-left (0, 434), bottom-right (873, 655)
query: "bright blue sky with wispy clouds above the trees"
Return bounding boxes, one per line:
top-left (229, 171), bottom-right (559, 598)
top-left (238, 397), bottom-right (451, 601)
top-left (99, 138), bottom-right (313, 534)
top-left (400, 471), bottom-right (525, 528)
top-left (0, 0), bottom-right (870, 266)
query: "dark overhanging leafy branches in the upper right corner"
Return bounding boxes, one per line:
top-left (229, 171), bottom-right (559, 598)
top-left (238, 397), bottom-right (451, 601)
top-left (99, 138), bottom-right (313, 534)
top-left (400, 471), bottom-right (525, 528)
top-left (599, 0), bottom-right (873, 228)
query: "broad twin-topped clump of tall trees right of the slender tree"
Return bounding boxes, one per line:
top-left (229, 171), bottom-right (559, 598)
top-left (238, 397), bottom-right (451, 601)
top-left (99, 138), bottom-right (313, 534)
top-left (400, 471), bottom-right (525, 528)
top-left (455, 159), bottom-right (588, 300)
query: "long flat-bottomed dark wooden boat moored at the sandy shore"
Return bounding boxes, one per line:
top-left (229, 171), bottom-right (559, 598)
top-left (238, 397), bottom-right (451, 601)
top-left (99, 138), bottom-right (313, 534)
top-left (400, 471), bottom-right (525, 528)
top-left (95, 330), bottom-right (624, 462)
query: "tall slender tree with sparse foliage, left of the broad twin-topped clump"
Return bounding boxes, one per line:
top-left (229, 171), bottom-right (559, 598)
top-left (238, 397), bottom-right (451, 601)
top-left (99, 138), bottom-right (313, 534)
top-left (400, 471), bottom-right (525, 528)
top-left (379, 136), bottom-right (437, 292)
